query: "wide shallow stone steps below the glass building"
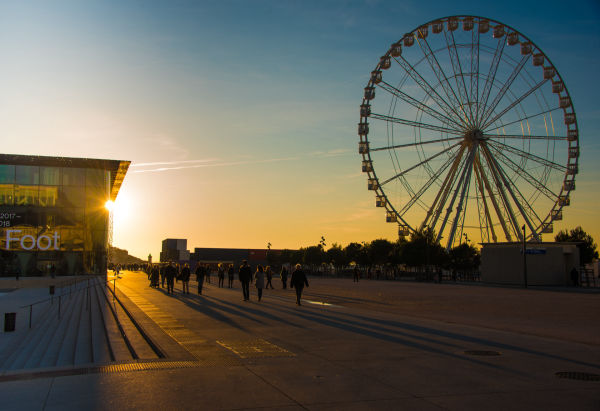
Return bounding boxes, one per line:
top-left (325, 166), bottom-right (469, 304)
top-left (0, 281), bottom-right (159, 374)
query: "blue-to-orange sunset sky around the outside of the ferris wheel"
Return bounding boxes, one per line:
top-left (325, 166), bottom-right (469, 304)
top-left (0, 0), bottom-right (600, 258)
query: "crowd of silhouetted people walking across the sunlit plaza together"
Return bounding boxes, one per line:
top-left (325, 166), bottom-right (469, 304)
top-left (144, 260), bottom-right (308, 305)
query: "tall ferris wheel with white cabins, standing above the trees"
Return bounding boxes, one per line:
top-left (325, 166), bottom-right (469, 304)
top-left (358, 16), bottom-right (579, 249)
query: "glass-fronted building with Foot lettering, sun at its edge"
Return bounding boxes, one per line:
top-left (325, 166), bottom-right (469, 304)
top-left (0, 154), bottom-right (130, 276)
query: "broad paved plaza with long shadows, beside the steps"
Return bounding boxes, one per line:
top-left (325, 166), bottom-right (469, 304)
top-left (0, 272), bottom-right (600, 410)
